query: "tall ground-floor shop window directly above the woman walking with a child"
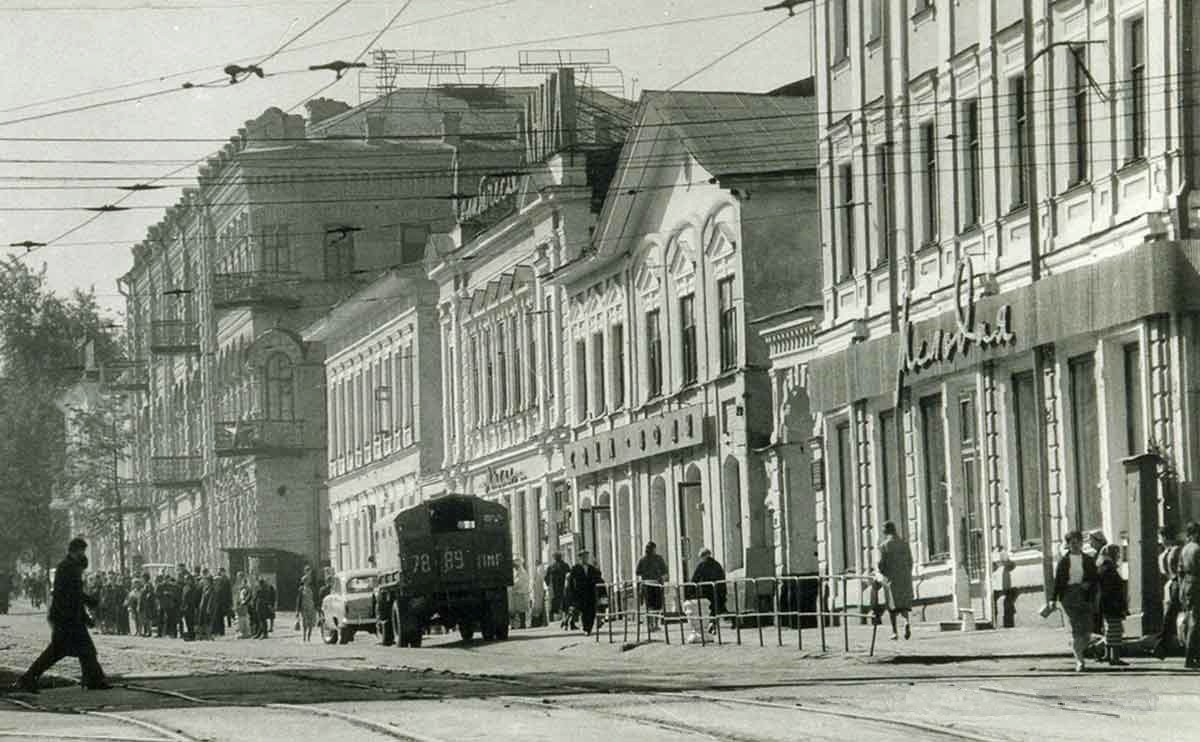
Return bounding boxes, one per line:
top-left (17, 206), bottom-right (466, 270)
top-left (1067, 353), bottom-right (1104, 529)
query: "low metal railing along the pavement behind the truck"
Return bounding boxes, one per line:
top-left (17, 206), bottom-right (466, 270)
top-left (594, 574), bottom-right (878, 656)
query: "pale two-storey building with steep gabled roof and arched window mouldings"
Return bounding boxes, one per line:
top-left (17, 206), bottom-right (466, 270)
top-left (553, 86), bottom-right (818, 580)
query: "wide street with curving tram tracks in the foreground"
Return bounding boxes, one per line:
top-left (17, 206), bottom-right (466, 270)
top-left (0, 605), bottom-right (1200, 742)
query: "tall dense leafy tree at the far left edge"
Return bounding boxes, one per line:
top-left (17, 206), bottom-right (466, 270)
top-left (0, 257), bottom-right (120, 566)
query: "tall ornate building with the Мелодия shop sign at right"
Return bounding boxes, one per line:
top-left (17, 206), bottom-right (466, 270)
top-left (808, 0), bottom-right (1200, 621)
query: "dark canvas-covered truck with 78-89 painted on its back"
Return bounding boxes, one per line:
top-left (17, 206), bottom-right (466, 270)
top-left (376, 495), bottom-right (512, 647)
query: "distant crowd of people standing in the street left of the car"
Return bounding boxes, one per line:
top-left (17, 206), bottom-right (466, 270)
top-left (78, 564), bottom-right (276, 641)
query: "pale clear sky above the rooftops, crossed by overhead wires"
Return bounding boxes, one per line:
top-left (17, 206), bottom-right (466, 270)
top-left (0, 0), bottom-right (811, 313)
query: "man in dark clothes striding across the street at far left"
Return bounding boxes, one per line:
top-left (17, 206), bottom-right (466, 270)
top-left (16, 538), bottom-right (112, 693)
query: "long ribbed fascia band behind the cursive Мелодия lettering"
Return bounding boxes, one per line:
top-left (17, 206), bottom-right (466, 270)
top-left (809, 240), bottom-right (1200, 412)
